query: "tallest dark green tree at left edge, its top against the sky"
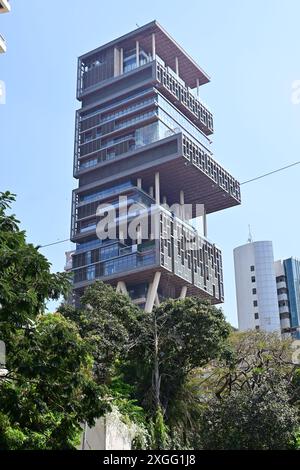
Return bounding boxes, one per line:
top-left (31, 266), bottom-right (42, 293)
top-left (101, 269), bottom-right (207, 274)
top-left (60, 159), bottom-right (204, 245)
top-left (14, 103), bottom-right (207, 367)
top-left (0, 192), bottom-right (70, 332)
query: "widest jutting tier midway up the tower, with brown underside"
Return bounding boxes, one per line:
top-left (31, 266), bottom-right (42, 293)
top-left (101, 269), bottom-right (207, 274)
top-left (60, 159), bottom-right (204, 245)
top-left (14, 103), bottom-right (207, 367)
top-left (76, 132), bottom-right (241, 213)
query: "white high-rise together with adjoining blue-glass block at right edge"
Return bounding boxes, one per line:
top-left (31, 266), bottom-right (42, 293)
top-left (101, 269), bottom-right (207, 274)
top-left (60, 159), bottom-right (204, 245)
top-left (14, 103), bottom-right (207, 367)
top-left (234, 241), bottom-right (300, 338)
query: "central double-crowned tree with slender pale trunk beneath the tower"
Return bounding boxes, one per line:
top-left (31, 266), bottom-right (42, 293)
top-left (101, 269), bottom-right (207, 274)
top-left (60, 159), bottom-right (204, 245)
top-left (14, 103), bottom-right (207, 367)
top-left (60, 282), bottom-right (230, 448)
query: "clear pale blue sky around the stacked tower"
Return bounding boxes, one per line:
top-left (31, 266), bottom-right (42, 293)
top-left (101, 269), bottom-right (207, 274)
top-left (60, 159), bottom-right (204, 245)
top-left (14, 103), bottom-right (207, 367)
top-left (0, 0), bottom-right (300, 324)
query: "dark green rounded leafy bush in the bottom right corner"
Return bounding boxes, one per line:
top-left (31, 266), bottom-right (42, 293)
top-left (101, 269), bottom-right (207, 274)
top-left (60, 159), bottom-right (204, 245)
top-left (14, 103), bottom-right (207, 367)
top-left (200, 383), bottom-right (299, 450)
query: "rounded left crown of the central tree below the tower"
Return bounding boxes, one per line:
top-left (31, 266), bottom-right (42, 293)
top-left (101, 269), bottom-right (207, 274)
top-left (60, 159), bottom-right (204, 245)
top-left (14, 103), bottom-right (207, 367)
top-left (59, 281), bottom-right (143, 384)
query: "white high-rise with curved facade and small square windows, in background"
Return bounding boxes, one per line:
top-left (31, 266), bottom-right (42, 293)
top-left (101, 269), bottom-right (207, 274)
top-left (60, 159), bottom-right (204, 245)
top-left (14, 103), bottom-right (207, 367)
top-left (234, 241), bottom-right (281, 333)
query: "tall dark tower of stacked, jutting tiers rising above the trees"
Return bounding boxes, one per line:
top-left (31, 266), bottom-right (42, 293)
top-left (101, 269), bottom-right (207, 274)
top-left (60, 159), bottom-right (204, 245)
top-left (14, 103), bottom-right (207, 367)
top-left (71, 21), bottom-right (240, 312)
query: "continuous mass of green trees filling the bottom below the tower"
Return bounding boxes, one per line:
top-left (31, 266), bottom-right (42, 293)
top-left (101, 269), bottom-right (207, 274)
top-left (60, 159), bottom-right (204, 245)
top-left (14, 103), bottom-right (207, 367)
top-left (0, 193), bottom-right (300, 450)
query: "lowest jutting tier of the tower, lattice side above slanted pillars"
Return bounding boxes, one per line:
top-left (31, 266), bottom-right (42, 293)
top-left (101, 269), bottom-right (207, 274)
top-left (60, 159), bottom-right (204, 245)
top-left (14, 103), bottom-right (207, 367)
top-left (73, 207), bottom-right (223, 303)
